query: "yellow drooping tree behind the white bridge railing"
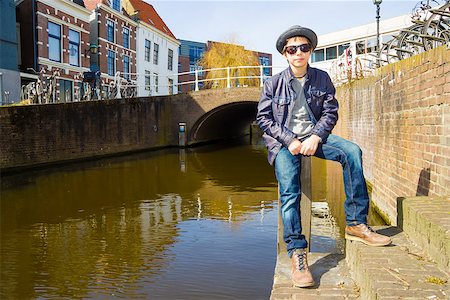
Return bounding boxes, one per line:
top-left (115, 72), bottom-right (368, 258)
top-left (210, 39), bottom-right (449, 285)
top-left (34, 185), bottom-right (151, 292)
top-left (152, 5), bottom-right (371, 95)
top-left (199, 42), bottom-right (260, 88)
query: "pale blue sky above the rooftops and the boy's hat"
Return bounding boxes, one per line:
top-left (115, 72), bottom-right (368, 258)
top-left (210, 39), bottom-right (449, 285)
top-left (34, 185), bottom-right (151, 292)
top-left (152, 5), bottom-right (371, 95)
top-left (150, 0), bottom-right (419, 66)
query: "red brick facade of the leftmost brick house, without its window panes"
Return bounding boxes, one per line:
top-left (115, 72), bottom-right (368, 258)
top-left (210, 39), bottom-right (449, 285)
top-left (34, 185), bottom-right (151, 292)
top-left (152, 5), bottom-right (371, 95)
top-left (17, 1), bottom-right (90, 102)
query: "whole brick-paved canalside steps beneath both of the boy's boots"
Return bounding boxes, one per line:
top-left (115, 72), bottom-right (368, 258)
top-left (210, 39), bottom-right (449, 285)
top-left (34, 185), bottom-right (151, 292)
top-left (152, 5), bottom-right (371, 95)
top-left (271, 197), bottom-right (450, 300)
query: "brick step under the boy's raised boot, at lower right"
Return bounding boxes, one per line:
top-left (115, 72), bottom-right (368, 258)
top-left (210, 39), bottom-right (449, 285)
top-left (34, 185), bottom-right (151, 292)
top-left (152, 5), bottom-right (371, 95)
top-left (346, 226), bottom-right (450, 300)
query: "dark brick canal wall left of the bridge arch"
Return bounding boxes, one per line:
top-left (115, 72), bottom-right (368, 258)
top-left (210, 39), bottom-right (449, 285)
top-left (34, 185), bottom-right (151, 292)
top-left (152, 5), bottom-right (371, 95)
top-left (0, 97), bottom-right (178, 170)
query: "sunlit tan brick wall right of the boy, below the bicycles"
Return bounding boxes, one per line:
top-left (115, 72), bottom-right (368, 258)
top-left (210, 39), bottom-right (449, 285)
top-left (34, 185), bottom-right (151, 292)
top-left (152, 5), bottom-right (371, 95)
top-left (328, 47), bottom-right (450, 224)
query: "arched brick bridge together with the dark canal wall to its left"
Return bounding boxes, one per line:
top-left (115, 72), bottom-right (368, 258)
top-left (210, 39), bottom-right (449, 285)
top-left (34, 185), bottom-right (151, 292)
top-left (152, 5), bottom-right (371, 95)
top-left (0, 87), bottom-right (261, 171)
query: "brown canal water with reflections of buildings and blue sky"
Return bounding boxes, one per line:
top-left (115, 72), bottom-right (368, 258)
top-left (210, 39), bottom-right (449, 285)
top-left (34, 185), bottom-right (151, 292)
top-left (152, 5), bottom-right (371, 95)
top-left (0, 145), bottom-right (277, 299)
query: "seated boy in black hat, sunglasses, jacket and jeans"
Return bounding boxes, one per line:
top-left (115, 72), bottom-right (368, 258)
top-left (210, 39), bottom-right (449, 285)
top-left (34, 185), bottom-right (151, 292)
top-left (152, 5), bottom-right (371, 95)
top-left (256, 25), bottom-right (391, 287)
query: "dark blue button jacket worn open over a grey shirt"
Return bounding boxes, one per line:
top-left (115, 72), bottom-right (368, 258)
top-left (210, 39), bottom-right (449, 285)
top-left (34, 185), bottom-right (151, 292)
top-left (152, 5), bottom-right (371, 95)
top-left (256, 65), bottom-right (339, 165)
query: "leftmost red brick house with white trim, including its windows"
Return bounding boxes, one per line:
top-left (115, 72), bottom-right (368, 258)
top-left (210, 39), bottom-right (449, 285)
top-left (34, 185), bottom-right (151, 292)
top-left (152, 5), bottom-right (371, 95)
top-left (16, 0), bottom-right (91, 103)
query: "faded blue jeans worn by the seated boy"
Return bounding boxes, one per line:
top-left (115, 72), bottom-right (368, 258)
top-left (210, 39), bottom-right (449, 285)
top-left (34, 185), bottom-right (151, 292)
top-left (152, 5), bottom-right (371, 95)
top-left (275, 134), bottom-right (369, 256)
